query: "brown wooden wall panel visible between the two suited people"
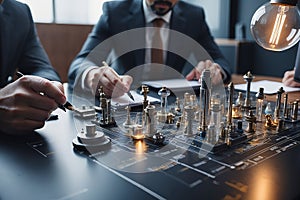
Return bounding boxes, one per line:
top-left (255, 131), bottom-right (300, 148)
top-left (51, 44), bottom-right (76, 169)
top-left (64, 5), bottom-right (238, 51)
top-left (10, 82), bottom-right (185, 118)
top-left (36, 23), bottom-right (93, 82)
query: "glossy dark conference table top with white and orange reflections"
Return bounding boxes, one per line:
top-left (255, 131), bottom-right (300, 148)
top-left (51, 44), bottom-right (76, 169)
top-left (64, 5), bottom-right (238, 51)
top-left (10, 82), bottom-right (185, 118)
top-left (0, 75), bottom-right (300, 200)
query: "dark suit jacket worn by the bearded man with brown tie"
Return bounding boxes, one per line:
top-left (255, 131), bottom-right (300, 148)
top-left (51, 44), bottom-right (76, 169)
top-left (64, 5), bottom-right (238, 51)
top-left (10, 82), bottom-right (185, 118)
top-left (69, 0), bottom-right (231, 86)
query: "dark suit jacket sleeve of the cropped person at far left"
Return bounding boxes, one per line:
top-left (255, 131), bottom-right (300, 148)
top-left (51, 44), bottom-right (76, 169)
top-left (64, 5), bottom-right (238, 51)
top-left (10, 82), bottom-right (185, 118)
top-left (0, 0), bottom-right (60, 87)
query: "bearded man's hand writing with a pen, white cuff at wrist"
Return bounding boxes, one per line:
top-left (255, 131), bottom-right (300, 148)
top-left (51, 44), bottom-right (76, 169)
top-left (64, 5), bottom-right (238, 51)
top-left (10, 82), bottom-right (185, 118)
top-left (86, 66), bottom-right (133, 97)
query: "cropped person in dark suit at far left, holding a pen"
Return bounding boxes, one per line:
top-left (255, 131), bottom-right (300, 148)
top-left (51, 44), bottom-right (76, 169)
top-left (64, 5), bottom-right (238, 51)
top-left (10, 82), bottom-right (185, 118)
top-left (0, 0), bottom-right (66, 134)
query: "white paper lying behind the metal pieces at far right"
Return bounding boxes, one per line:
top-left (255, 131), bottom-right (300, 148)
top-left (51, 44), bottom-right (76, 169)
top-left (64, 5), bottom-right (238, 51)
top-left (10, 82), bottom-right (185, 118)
top-left (234, 80), bottom-right (300, 94)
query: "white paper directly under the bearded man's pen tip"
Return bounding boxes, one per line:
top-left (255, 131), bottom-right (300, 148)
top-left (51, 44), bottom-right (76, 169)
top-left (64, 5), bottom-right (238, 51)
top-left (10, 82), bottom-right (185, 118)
top-left (111, 90), bottom-right (160, 107)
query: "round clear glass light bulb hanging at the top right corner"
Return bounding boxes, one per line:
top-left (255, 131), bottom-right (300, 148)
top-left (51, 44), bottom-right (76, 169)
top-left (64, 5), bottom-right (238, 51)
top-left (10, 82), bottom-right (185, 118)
top-left (250, 0), bottom-right (300, 51)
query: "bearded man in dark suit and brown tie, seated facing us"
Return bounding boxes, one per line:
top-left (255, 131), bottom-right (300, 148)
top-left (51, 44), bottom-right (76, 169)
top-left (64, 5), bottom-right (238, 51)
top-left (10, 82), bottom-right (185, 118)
top-left (69, 0), bottom-right (231, 96)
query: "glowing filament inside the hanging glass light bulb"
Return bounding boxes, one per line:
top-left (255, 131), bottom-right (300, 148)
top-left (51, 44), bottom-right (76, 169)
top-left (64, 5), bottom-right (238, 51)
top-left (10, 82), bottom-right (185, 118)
top-left (269, 6), bottom-right (286, 45)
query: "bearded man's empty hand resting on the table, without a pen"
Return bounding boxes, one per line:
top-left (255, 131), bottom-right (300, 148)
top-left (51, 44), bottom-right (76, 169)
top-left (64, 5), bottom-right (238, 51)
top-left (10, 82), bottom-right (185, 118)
top-left (186, 60), bottom-right (223, 85)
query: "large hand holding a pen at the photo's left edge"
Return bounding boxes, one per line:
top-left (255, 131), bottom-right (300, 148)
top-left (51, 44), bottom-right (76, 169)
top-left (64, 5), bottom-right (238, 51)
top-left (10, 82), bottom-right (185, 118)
top-left (0, 76), bottom-right (66, 135)
